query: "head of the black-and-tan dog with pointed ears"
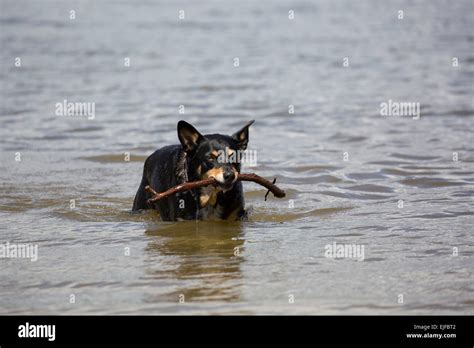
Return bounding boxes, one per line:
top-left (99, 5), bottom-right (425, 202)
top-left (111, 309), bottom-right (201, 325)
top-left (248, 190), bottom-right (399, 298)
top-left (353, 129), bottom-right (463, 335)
top-left (178, 121), bottom-right (254, 191)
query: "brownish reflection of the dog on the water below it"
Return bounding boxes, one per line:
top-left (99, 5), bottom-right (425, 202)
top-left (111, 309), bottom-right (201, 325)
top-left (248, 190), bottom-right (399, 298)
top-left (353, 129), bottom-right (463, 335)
top-left (145, 221), bottom-right (244, 302)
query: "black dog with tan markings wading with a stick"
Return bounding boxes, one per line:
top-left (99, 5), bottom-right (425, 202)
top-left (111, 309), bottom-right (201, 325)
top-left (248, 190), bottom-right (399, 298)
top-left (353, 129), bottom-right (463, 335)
top-left (133, 121), bottom-right (254, 221)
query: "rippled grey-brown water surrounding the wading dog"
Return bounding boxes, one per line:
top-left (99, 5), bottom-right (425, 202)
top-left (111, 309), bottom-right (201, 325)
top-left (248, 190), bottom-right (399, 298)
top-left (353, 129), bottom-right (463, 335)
top-left (0, 0), bottom-right (474, 314)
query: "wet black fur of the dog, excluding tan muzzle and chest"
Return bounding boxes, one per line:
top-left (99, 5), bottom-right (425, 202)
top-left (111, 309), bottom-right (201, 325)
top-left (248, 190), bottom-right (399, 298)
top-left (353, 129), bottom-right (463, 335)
top-left (132, 121), bottom-right (253, 221)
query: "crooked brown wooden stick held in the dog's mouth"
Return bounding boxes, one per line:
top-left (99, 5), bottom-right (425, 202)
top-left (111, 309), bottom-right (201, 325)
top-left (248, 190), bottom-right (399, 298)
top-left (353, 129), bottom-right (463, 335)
top-left (145, 173), bottom-right (286, 203)
